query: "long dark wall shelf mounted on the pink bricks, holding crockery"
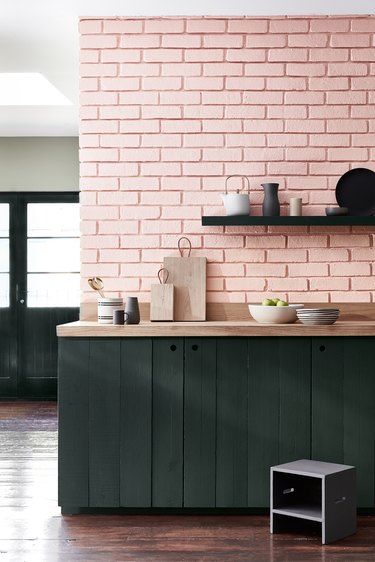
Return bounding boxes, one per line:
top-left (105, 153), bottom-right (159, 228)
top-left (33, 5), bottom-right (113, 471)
top-left (202, 215), bottom-right (375, 226)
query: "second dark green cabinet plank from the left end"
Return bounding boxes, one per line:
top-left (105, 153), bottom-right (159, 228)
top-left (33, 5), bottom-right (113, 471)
top-left (89, 338), bottom-right (120, 507)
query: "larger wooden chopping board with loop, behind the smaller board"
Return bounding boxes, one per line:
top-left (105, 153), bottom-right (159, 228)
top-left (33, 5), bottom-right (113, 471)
top-left (163, 237), bottom-right (207, 322)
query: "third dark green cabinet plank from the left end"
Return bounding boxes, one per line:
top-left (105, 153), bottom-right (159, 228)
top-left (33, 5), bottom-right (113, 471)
top-left (120, 338), bottom-right (152, 507)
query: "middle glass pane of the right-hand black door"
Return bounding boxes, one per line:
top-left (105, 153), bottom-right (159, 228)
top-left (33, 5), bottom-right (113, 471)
top-left (27, 238), bottom-right (79, 273)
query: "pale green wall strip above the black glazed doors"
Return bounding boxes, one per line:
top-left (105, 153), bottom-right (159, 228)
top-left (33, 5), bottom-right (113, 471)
top-left (0, 137), bottom-right (79, 191)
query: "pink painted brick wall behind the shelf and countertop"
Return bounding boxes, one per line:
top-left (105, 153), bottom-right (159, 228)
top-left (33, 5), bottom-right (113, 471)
top-left (80, 16), bottom-right (375, 302)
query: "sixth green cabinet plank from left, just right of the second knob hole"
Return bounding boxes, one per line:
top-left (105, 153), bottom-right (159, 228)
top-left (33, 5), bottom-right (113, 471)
top-left (216, 338), bottom-right (248, 507)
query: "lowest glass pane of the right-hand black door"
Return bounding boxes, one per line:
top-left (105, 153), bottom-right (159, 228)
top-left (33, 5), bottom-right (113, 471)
top-left (27, 273), bottom-right (80, 308)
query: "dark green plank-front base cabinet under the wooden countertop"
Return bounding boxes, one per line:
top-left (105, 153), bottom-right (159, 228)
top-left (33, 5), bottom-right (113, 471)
top-left (59, 337), bottom-right (375, 512)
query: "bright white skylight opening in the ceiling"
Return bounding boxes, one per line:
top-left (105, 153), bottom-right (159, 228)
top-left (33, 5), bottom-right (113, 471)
top-left (0, 72), bottom-right (73, 105)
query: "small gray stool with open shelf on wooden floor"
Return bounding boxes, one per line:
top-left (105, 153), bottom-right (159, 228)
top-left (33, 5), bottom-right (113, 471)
top-left (270, 459), bottom-right (357, 544)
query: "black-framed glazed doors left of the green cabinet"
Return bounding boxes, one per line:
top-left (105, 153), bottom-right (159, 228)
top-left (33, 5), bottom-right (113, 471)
top-left (0, 192), bottom-right (80, 398)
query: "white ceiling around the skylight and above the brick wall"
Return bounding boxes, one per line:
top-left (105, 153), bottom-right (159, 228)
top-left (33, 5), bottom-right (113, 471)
top-left (0, 0), bottom-right (375, 137)
